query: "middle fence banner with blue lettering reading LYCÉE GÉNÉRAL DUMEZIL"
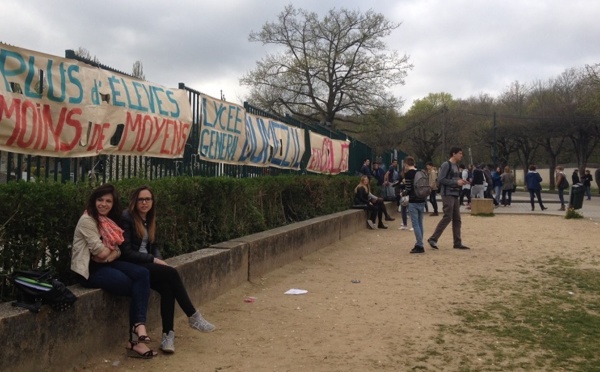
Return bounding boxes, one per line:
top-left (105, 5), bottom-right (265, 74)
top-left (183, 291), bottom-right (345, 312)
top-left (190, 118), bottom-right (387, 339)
top-left (198, 95), bottom-right (305, 170)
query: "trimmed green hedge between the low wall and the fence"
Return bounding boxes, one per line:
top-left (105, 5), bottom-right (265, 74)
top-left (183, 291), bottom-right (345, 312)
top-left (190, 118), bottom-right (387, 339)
top-left (0, 175), bottom-right (358, 297)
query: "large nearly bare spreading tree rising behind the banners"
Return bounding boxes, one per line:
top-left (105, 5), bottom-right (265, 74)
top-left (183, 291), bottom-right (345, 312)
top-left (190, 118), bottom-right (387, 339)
top-left (240, 5), bottom-right (412, 129)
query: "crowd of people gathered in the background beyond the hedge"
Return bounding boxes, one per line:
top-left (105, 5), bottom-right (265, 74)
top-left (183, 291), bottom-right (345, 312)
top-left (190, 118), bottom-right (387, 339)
top-left (355, 147), bottom-right (593, 253)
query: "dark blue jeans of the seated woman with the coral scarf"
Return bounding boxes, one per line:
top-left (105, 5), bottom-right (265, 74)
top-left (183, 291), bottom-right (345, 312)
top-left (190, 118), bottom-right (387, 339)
top-left (81, 260), bottom-right (150, 327)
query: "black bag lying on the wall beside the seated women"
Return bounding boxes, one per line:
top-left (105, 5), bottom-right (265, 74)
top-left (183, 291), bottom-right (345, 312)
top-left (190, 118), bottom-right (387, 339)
top-left (10, 270), bottom-right (77, 313)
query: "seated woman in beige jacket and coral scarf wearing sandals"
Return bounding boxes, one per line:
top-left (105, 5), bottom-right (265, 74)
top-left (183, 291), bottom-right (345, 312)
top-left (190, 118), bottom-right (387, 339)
top-left (71, 184), bottom-right (157, 359)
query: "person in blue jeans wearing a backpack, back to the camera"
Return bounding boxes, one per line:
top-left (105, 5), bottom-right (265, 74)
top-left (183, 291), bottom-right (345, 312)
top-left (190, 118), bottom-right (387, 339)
top-left (404, 156), bottom-right (431, 253)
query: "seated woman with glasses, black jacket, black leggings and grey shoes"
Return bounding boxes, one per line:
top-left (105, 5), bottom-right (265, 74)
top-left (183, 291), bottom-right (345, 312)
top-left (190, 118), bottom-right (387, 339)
top-left (121, 186), bottom-right (215, 353)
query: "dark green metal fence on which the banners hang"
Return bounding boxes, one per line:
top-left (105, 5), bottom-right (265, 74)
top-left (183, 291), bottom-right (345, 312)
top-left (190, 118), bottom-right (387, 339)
top-left (0, 50), bottom-right (393, 183)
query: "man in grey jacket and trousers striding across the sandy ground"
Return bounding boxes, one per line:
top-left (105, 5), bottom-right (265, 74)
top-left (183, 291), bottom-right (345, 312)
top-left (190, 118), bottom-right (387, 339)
top-left (427, 147), bottom-right (469, 249)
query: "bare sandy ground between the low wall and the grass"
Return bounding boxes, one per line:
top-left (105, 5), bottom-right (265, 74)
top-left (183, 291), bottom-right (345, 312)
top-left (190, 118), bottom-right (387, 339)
top-left (75, 215), bottom-right (600, 371)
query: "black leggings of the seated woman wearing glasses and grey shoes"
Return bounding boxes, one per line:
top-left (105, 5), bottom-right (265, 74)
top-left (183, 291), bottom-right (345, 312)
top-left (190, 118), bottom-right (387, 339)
top-left (141, 263), bottom-right (196, 334)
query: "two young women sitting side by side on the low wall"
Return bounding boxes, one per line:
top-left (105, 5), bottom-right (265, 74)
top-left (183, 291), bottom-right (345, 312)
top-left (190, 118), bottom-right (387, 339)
top-left (71, 184), bottom-right (215, 359)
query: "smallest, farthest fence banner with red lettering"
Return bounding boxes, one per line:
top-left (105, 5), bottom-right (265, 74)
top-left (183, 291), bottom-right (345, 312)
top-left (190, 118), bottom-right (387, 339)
top-left (306, 132), bottom-right (350, 174)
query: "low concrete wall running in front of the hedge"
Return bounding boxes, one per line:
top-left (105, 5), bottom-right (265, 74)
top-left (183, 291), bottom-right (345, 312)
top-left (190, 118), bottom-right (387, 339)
top-left (0, 203), bottom-right (376, 371)
